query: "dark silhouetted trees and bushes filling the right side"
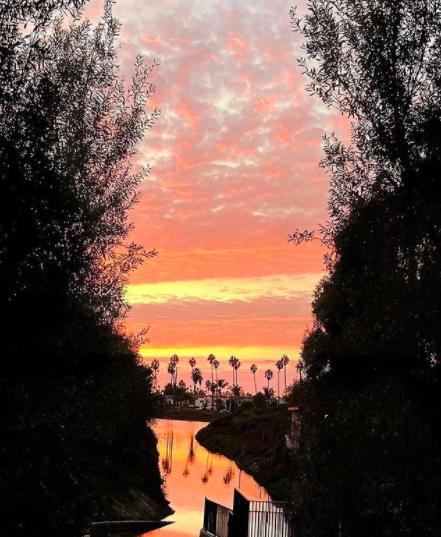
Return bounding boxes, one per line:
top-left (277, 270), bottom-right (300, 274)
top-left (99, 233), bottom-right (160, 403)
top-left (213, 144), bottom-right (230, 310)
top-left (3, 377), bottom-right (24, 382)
top-left (289, 0), bottom-right (441, 537)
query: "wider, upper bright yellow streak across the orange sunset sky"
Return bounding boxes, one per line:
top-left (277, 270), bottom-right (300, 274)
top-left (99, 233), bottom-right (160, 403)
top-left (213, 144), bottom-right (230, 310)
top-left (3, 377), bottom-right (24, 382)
top-left (126, 273), bottom-right (323, 304)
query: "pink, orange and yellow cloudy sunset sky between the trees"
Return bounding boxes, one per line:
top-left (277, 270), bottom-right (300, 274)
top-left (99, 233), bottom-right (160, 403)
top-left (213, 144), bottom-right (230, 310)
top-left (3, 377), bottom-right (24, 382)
top-left (87, 0), bottom-right (346, 390)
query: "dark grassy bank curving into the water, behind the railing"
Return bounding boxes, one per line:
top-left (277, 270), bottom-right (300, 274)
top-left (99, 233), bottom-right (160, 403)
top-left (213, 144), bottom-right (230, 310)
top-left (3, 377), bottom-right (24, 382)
top-left (196, 406), bottom-right (288, 500)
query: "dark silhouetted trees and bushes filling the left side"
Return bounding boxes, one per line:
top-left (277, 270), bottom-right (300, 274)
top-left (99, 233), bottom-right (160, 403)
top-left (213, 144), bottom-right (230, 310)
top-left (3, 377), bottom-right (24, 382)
top-left (0, 0), bottom-right (170, 537)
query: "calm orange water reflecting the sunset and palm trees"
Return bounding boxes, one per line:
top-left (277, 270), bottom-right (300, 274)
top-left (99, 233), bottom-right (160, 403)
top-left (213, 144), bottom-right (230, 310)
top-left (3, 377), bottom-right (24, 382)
top-left (145, 420), bottom-right (268, 537)
